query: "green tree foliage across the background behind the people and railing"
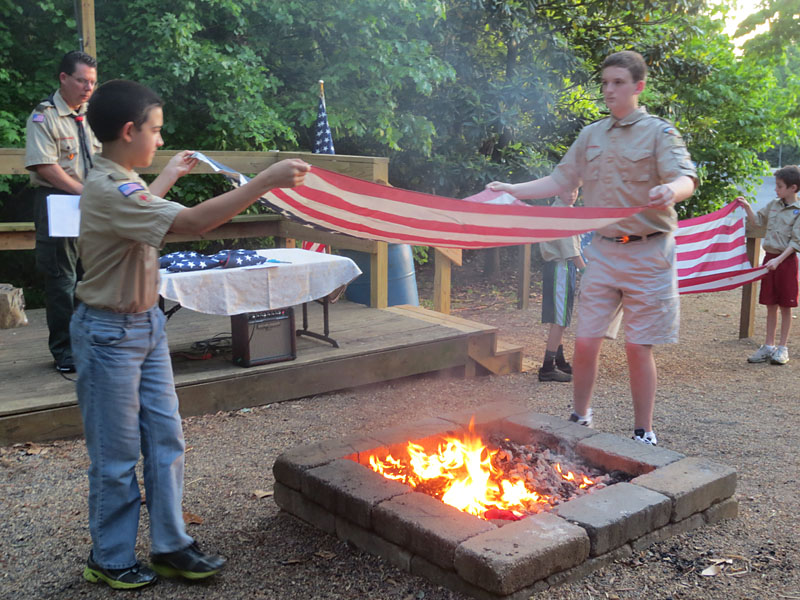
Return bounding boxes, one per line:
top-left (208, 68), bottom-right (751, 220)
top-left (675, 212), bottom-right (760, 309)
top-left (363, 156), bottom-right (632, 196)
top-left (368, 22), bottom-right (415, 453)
top-left (0, 0), bottom-right (798, 214)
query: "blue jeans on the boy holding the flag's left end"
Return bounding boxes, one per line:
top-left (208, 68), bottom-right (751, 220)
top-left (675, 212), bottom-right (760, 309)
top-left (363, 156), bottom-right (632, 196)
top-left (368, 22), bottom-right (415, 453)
top-left (70, 304), bottom-right (193, 569)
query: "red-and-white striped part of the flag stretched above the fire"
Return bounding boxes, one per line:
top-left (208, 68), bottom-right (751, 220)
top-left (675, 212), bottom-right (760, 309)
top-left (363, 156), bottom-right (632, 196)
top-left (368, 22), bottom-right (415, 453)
top-left (262, 167), bottom-right (641, 249)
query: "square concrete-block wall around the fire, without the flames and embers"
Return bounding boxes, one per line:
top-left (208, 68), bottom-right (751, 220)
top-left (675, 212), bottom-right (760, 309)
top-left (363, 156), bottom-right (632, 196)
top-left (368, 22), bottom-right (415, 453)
top-left (273, 404), bottom-right (738, 600)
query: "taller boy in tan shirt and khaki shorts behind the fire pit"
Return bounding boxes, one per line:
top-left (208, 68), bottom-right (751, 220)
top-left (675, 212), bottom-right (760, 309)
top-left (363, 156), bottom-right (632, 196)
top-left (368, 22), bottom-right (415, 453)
top-left (489, 51), bottom-right (697, 445)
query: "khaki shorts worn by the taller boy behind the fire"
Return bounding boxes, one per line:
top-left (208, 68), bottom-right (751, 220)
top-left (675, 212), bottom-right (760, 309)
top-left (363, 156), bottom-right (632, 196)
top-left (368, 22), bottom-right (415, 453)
top-left (575, 233), bottom-right (680, 345)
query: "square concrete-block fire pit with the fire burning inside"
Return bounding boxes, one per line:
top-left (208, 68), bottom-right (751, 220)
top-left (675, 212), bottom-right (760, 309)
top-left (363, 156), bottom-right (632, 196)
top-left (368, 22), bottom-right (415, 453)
top-left (273, 405), bottom-right (738, 599)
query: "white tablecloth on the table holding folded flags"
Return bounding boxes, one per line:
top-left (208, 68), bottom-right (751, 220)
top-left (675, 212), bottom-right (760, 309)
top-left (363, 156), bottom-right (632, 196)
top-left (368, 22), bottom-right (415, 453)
top-left (159, 248), bottom-right (361, 315)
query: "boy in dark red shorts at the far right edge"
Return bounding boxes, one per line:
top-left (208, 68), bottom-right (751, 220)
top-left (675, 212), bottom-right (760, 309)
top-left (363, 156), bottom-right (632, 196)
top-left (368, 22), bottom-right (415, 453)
top-left (736, 165), bottom-right (800, 365)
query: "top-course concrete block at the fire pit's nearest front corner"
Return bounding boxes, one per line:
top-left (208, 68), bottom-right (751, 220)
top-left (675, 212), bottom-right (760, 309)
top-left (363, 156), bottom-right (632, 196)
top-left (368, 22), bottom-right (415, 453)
top-left (455, 513), bottom-right (589, 596)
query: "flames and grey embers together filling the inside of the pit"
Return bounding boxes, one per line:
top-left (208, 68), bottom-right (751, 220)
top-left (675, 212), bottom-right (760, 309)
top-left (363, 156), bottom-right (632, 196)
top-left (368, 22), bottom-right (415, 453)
top-left (369, 426), bottom-right (616, 521)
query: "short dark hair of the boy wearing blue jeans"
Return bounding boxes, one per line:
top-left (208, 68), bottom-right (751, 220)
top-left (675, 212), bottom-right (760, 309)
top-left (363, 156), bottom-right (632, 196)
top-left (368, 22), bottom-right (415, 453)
top-left (86, 79), bottom-right (164, 143)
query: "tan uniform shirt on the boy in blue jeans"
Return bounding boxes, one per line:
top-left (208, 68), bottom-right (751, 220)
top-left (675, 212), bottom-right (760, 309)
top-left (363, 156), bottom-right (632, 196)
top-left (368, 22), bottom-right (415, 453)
top-left (75, 156), bottom-right (185, 313)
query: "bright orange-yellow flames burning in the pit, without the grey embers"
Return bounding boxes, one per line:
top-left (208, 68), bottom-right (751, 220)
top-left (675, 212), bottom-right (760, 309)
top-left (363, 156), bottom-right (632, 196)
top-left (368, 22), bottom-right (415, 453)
top-left (369, 427), bottom-right (593, 518)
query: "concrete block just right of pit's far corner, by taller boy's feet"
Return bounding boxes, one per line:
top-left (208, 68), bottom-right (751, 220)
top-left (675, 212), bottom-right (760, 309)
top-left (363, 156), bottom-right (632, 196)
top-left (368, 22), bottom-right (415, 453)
top-left (504, 412), bottom-right (599, 456)
